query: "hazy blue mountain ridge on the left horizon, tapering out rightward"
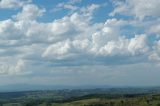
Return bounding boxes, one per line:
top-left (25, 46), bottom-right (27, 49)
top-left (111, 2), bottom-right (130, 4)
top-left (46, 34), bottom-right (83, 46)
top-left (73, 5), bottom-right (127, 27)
top-left (0, 84), bottom-right (113, 92)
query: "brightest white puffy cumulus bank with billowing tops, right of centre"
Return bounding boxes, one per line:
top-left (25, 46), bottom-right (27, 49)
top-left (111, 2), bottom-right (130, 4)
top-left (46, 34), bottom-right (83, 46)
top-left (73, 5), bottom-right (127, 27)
top-left (42, 16), bottom-right (150, 60)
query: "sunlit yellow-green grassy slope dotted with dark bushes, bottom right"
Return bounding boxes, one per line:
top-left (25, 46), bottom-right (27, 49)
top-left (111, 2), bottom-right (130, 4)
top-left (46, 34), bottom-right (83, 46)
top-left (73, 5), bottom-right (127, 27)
top-left (48, 95), bottom-right (160, 106)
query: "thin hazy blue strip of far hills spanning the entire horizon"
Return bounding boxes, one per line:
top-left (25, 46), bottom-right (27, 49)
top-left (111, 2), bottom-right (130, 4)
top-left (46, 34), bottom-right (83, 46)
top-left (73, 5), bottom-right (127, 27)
top-left (0, 84), bottom-right (160, 92)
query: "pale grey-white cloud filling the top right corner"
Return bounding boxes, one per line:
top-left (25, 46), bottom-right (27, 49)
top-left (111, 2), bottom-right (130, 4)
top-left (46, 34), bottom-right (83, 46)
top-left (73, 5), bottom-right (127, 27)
top-left (110, 0), bottom-right (160, 20)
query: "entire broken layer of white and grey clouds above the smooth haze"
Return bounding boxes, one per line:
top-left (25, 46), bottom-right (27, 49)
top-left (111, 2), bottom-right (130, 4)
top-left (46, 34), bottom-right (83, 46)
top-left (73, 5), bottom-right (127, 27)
top-left (0, 0), bottom-right (160, 86)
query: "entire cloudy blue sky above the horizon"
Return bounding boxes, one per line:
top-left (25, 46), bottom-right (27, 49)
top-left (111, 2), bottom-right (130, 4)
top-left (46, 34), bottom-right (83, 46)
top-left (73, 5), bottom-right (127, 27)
top-left (0, 0), bottom-right (160, 86)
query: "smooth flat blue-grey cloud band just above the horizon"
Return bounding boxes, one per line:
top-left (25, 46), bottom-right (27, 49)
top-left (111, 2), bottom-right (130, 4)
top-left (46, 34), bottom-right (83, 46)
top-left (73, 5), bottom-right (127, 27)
top-left (0, 63), bottom-right (160, 86)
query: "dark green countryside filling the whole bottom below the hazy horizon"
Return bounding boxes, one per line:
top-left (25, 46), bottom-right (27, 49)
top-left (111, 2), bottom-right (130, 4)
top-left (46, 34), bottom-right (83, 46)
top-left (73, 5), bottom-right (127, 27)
top-left (0, 88), bottom-right (160, 106)
